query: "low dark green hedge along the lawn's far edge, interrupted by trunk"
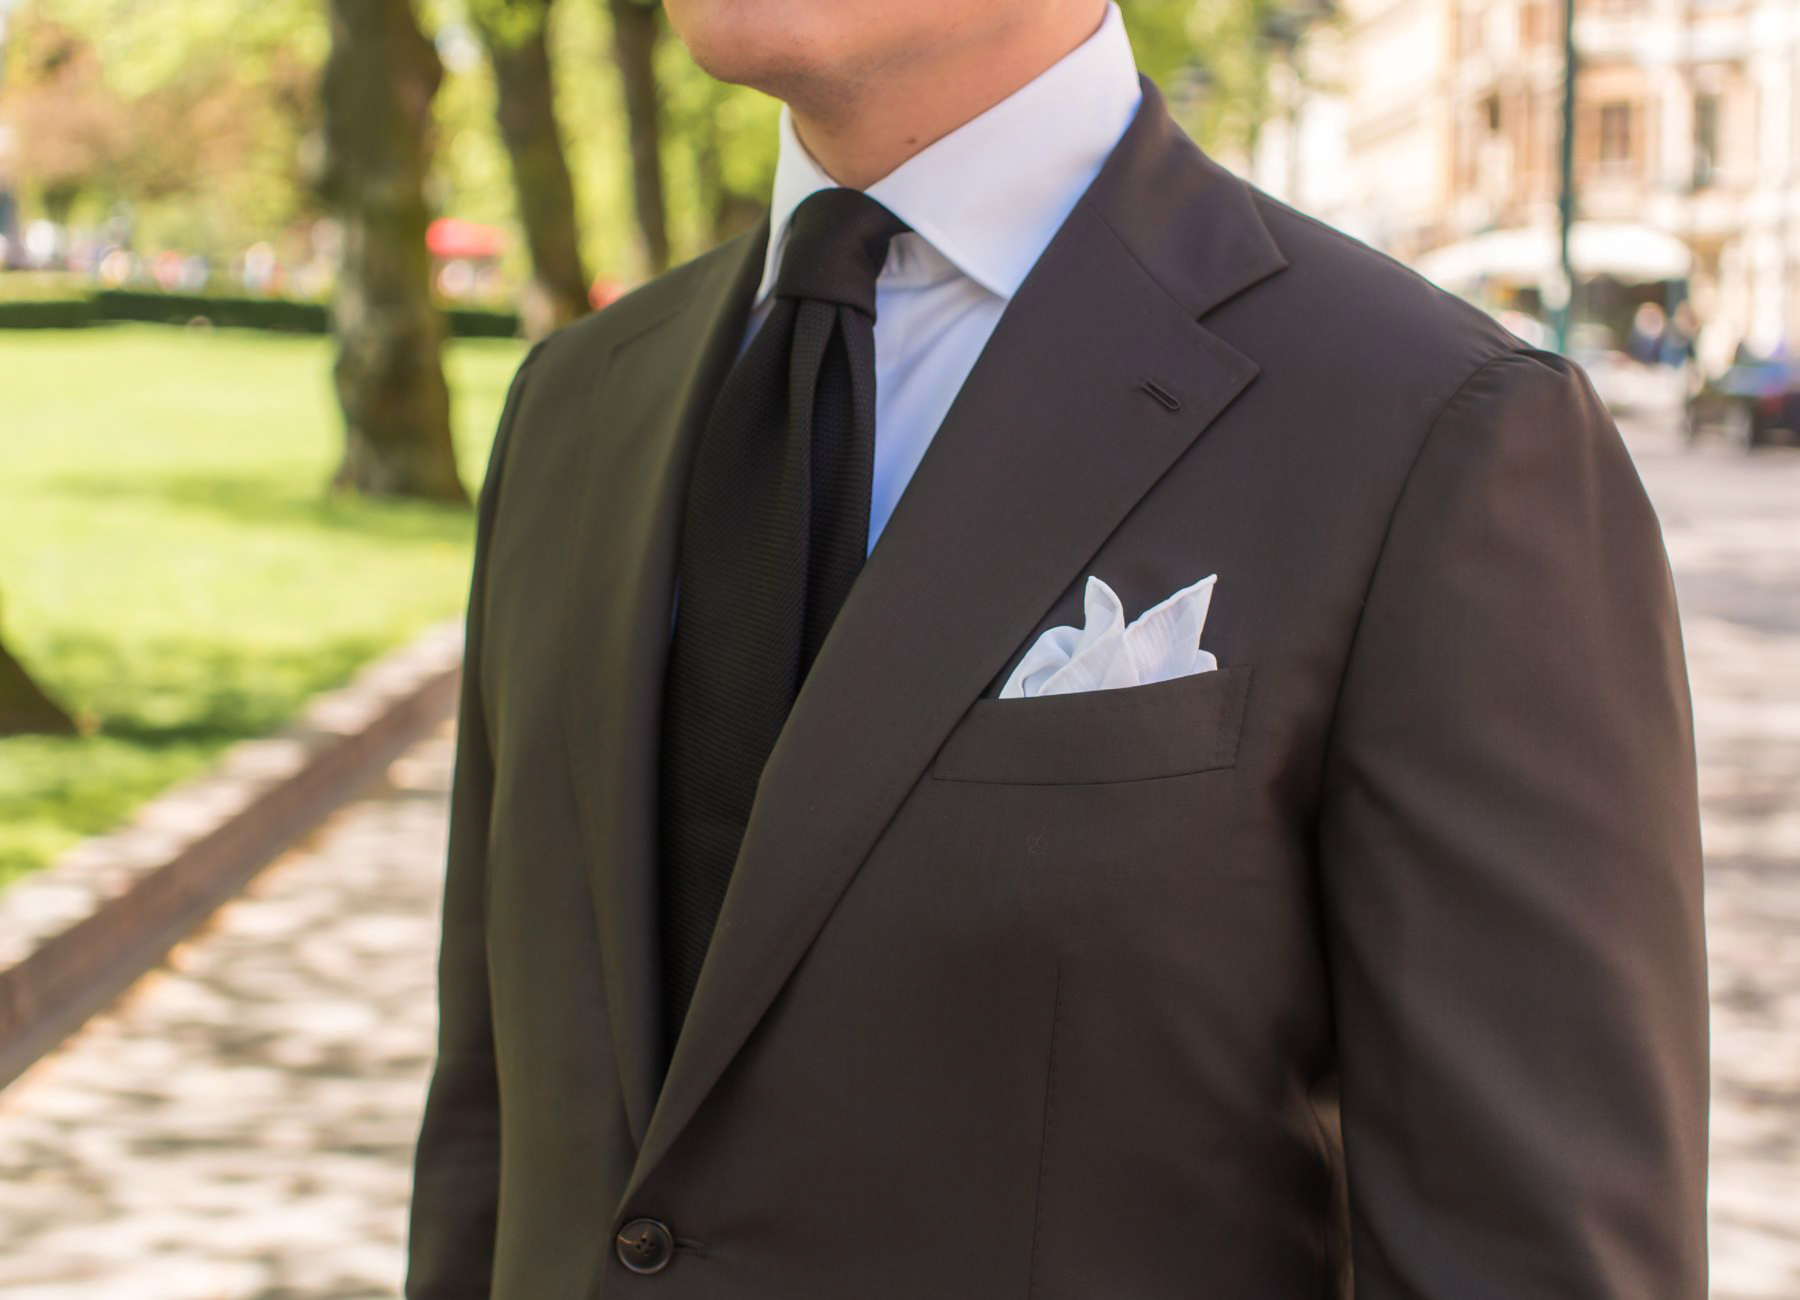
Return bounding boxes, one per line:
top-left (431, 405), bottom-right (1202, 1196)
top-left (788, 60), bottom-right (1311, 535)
top-left (0, 288), bottom-right (518, 339)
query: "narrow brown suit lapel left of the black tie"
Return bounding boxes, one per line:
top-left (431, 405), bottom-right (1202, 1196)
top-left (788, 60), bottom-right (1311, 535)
top-left (562, 221), bottom-right (767, 1143)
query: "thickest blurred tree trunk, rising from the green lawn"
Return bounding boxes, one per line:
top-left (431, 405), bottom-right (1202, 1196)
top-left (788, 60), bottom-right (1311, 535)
top-left (324, 0), bottom-right (468, 504)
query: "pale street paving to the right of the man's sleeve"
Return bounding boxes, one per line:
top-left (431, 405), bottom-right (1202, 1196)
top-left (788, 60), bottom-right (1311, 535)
top-left (1627, 423), bottom-right (1800, 1300)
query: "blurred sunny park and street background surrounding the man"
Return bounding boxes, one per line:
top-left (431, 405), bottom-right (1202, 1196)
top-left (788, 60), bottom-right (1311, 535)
top-left (0, 0), bottom-right (1800, 1300)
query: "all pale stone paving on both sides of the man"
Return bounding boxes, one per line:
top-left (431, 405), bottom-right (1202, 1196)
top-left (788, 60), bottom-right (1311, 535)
top-left (0, 410), bottom-right (1800, 1300)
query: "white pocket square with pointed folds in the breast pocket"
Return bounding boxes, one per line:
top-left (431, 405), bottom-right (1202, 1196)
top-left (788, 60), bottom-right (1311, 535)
top-left (1001, 574), bottom-right (1219, 700)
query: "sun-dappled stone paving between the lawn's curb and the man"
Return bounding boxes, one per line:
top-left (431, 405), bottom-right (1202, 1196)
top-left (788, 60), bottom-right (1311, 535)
top-left (0, 727), bottom-right (452, 1300)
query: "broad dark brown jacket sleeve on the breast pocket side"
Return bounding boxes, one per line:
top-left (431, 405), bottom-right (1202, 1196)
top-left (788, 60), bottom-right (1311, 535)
top-left (1319, 351), bottom-right (1706, 1300)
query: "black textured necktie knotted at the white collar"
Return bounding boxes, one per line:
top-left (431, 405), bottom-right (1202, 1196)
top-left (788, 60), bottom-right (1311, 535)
top-left (659, 189), bottom-right (907, 1048)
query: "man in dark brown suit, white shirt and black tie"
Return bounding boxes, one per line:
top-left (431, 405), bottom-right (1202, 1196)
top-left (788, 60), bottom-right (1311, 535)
top-left (409, 0), bottom-right (1706, 1300)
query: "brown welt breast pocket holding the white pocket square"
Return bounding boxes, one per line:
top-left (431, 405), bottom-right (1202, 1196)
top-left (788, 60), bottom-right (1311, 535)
top-left (931, 664), bottom-right (1249, 785)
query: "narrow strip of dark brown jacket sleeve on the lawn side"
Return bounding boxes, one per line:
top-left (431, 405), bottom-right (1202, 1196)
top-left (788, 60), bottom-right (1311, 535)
top-left (405, 343), bottom-right (536, 1300)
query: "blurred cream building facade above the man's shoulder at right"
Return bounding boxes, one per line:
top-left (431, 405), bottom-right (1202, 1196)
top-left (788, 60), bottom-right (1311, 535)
top-left (1249, 0), bottom-right (1800, 367)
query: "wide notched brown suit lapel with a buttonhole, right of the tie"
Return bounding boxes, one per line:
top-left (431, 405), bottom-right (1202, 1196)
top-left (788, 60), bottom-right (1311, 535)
top-left (621, 81), bottom-right (1283, 1205)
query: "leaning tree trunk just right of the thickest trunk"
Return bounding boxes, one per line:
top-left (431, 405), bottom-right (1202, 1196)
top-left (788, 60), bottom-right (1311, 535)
top-left (470, 0), bottom-right (589, 339)
